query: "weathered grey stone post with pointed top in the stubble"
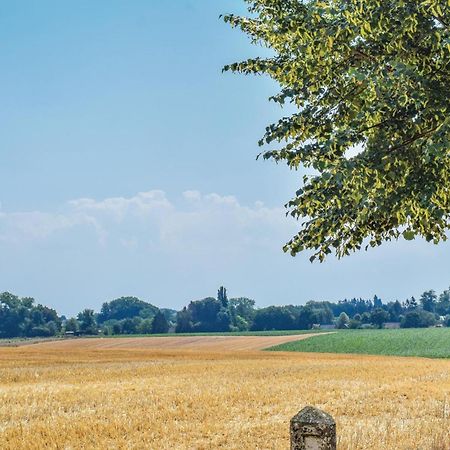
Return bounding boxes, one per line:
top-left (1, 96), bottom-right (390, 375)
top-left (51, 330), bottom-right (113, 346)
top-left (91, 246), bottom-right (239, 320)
top-left (291, 406), bottom-right (336, 450)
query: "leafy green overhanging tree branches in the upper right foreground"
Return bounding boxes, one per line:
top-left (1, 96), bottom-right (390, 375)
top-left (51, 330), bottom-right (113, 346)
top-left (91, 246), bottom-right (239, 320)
top-left (224, 0), bottom-right (450, 261)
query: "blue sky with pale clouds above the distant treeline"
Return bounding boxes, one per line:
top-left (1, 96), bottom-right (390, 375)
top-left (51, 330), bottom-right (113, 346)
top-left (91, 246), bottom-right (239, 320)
top-left (0, 0), bottom-right (450, 314)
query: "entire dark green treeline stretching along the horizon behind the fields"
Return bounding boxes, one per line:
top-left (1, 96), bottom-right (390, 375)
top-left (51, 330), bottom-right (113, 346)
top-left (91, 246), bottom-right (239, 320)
top-left (0, 287), bottom-right (450, 338)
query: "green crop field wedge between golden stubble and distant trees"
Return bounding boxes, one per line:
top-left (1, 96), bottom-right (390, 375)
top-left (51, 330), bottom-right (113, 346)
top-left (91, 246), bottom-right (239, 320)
top-left (268, 328), bottom-right (450, 358)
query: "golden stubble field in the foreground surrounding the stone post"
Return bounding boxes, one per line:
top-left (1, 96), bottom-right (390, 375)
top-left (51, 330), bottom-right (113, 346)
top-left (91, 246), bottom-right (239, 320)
top-left (0, 338), bottom-right (450, 450)
